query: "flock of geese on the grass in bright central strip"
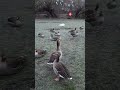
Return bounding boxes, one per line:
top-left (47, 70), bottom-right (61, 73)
top-left (35, 26), bottom-right (84, 81)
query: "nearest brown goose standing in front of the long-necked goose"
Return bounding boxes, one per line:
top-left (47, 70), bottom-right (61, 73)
top-left (53, 56), bottom-right (72, 81)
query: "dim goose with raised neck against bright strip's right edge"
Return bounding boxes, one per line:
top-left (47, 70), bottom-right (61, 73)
top-left (85, 3), bottom-right (99, 23)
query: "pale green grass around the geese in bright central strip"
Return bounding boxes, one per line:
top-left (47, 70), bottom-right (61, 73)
top-left (35, 20), bottom-right (85, 90)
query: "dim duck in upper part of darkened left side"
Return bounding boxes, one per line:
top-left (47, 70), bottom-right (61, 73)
top-left (8, 16), bottom-right (23, 27)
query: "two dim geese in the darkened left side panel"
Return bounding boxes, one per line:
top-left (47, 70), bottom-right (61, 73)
top-left (0, 16), bottom-right (26, 76)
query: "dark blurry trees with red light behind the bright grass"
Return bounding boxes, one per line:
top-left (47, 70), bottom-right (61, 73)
top-left (35, 0), bottom-right (85, 18)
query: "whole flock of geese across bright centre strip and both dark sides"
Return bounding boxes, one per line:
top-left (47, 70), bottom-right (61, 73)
top-left (0, 0), bottom-right (117, 77)
